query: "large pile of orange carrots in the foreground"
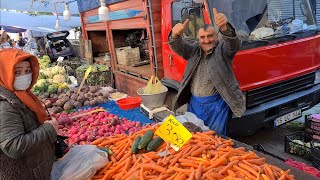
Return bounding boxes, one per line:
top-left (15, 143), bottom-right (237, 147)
top-left (90, 126), bottom-right (294, 180)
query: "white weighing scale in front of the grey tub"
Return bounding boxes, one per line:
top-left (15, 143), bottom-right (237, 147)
top-left (140, 104), bottom-right (174, 122)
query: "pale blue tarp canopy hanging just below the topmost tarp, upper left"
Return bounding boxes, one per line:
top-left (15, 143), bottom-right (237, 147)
top-left (0, 10), bottom-right (81, 32)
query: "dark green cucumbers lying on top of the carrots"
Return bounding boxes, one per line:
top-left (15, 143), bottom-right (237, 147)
top-left (131, 130), bottom-right (164, 154)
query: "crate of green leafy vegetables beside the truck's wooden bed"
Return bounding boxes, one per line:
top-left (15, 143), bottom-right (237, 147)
top-left (76, 64), bottom-right (111, 86)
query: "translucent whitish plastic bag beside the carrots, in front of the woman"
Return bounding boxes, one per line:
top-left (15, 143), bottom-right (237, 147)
top-left (51, 145), bottom-right (109, 180)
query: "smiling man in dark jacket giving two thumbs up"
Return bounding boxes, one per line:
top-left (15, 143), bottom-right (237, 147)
top-left (169, 9), bottom-right (245, 134)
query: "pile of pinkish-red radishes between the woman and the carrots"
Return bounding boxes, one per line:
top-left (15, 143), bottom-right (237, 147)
top-left (57, 107), bottom-right (154, 144)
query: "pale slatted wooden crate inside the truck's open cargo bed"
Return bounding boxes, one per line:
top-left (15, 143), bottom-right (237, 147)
top-left (116, 46), bottom-right (140, 66)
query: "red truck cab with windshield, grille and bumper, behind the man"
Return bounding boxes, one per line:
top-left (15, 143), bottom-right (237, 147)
top-left (161, 0), bottom-right (320, 135)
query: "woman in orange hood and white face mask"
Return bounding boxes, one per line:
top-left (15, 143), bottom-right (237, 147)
top-left (0, 49), bottom-right (58, 180)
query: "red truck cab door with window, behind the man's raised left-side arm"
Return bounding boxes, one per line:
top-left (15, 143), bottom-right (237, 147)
top-left (162, 0), bottom-right (205, 85)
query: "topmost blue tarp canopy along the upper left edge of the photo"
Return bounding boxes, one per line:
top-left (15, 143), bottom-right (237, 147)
top-left (0, 0), bottom-right (79, 14)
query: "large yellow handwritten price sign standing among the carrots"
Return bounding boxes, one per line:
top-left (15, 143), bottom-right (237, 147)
top-left (155, 115), bottom-right (192, 151)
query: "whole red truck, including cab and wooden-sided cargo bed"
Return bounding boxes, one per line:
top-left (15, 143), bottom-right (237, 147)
top-left (78, 0), bottom-right (320, 135)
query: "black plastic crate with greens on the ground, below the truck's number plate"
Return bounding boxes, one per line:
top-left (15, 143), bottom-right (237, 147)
top-left (284, 131), bottom-right (312, 159)
